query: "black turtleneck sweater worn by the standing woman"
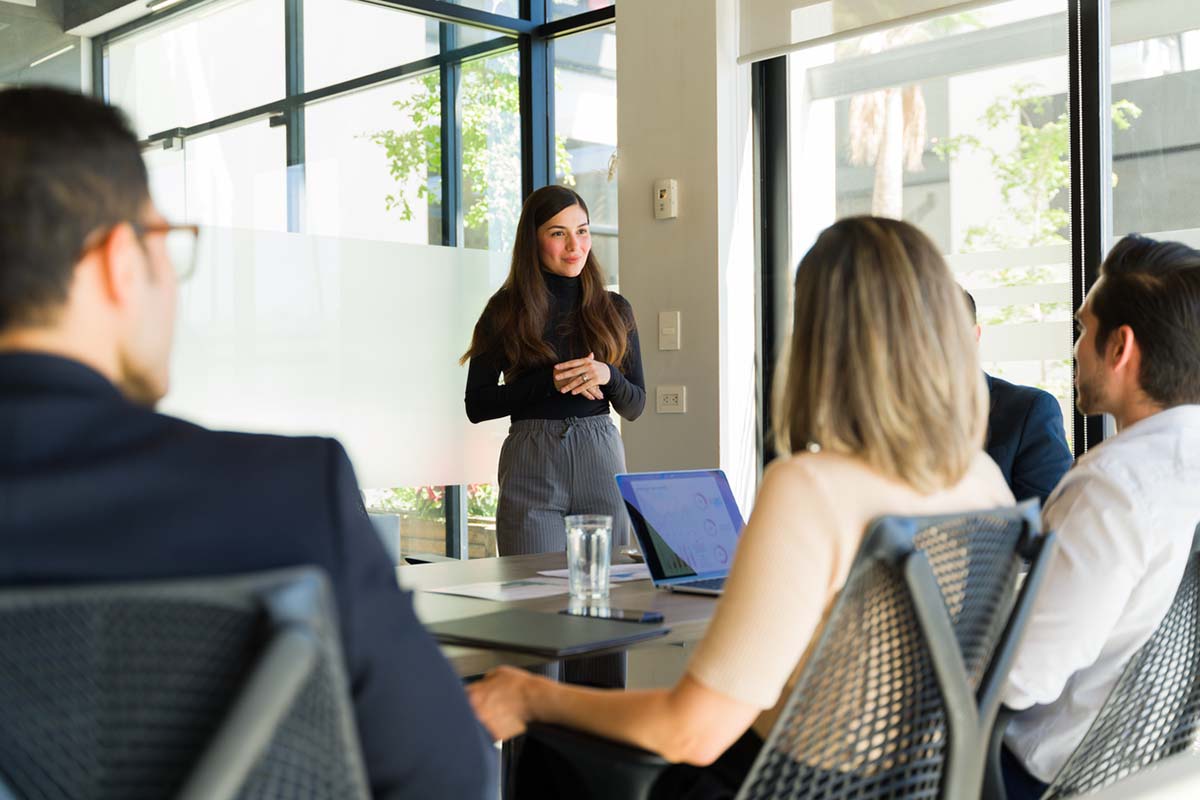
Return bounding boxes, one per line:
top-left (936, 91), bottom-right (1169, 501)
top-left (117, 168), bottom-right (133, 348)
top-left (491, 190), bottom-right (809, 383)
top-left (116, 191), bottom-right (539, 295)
top-left (466, 271), bottom-right (646, 422)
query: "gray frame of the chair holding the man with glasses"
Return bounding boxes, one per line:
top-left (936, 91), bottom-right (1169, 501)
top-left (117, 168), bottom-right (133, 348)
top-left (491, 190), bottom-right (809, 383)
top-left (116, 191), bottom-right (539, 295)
top-left (0, 567), bottom-right (370, 800)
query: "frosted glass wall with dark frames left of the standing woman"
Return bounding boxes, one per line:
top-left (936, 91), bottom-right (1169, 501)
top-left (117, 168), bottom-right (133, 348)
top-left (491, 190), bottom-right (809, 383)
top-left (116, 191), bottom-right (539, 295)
top-left (97, 0), bottom-right (616, 559)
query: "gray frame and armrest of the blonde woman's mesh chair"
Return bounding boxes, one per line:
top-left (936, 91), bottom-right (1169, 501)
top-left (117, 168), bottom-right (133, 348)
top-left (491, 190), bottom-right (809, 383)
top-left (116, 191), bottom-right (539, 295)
top-left (528, 501), bottom-right (1055, 800)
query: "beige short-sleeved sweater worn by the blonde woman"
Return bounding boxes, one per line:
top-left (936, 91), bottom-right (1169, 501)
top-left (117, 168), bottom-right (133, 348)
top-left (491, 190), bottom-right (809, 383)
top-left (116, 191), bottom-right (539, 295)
top-left (688, 451), bottom-right (1014, 738)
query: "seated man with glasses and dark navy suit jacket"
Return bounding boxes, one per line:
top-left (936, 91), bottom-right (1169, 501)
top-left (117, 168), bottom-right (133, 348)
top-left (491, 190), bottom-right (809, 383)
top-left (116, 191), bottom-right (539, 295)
top-left (0, 89), bottom-right (491, 799)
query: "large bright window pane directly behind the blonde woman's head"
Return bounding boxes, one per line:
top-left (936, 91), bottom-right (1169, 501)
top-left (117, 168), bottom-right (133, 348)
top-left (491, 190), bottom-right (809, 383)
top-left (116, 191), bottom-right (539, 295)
top-left (770, 0), bottom-right (1075, 443)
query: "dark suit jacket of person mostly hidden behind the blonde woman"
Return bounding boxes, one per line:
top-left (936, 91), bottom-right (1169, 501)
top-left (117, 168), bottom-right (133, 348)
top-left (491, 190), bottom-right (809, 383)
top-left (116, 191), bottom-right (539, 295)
top-left (986, 375), bottom-right (1072, 504)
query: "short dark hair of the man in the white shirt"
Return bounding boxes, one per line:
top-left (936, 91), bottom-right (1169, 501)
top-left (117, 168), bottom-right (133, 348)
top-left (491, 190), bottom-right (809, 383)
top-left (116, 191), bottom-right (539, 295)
top-left (1088, 234), bottom-right (1200, 408)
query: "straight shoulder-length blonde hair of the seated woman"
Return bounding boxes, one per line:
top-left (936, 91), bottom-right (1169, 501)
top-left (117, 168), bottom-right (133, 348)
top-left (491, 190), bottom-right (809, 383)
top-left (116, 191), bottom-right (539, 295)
top-left (775, 217), bottom-right (988, 494)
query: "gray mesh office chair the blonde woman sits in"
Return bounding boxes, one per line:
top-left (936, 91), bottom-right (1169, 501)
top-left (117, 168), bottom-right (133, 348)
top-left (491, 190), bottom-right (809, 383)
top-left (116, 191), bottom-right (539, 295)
top-left (518, 504), bottom-right (1054, 800)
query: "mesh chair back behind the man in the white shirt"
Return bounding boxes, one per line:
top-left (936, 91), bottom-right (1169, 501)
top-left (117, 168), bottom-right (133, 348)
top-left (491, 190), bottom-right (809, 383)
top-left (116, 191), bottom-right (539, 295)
top-left (1044, 527), bottom-right (1200, 800)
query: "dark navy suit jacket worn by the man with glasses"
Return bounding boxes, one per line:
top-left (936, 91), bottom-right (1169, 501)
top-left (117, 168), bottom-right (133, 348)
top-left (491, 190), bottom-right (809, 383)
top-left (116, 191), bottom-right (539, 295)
top-left (0, 354), bottom-right (494, 800)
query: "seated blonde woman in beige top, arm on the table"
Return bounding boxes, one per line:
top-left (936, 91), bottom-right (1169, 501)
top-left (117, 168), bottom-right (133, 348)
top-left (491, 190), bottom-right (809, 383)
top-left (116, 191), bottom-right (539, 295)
top-left (468, 217), bottom-right (1013, 798)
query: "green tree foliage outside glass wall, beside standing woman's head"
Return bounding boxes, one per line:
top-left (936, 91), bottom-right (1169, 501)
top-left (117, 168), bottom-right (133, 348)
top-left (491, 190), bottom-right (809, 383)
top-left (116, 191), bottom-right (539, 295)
top-left (365, 54), bottom-right (575, 249)
